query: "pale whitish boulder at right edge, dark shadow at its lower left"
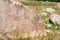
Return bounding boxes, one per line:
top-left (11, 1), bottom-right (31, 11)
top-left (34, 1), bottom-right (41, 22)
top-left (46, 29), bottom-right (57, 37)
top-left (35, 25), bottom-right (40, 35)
top-left (50, 13), bottom-right (60, 25)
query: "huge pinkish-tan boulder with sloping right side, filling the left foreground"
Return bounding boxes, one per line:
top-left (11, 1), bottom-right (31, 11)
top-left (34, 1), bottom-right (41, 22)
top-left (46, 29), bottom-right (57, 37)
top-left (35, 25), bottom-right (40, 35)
top-left (0, 0), bottom-right (46, 38)
